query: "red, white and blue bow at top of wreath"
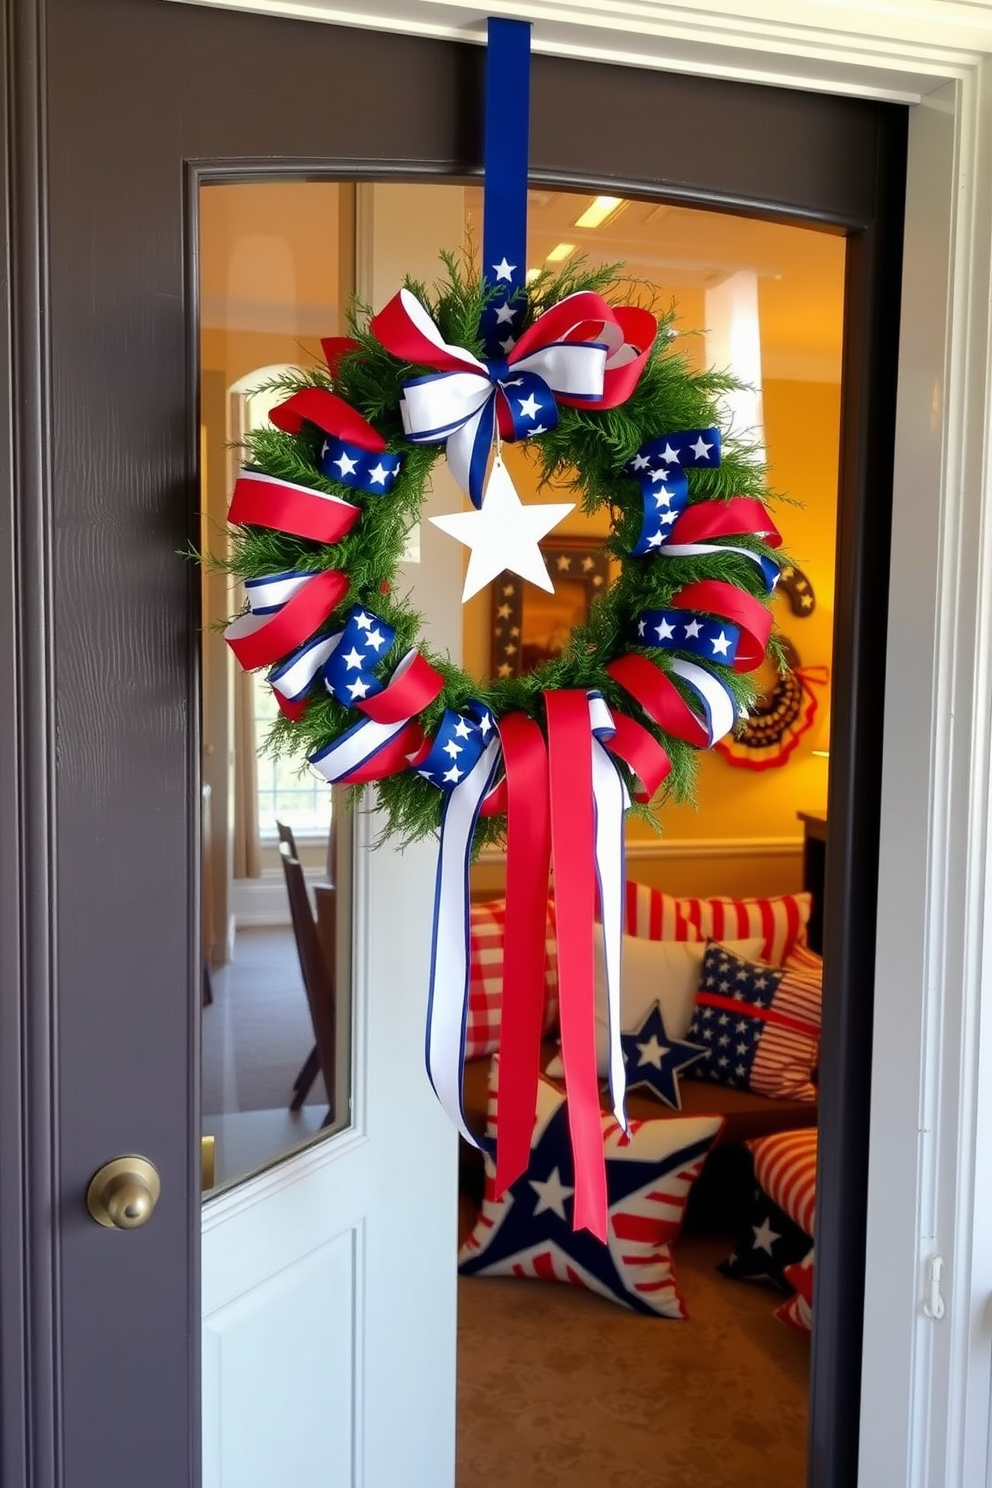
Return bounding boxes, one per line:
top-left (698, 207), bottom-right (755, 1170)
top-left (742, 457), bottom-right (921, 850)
top-left (370, 289), bottom-right (657, 506)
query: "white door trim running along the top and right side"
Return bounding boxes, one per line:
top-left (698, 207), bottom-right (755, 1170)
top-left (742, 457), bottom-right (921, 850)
top-left (171, 0), bottom-right (992, 1488)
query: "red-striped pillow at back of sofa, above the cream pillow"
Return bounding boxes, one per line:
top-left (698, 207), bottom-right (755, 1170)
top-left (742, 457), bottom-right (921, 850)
top-left (625, 879), bottom-right (812, 966)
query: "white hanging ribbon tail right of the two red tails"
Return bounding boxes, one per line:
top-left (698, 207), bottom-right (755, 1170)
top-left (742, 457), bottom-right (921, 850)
top-left (589, 692), bottom-right (631, 1131)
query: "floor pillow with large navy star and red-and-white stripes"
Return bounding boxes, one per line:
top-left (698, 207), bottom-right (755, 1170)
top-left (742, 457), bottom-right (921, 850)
top-left (458, 1055), bottom-right (723, 1318)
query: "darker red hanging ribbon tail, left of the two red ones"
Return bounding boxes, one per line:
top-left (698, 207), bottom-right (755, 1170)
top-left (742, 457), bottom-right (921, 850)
top-left (495, 713), bottom-right (552, 1198)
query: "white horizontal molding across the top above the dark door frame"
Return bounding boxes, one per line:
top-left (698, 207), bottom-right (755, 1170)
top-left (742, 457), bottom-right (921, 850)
top-left (166, 0), bottom-right (992, 103)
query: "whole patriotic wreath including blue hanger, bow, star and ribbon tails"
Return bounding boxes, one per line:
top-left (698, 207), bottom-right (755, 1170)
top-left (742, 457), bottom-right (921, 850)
top-left (214, 19), bottom-right (779, 1240)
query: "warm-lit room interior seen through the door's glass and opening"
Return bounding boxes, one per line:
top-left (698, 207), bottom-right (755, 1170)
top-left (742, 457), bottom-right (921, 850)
top-left (199, 182), bottom-right (845, 1488)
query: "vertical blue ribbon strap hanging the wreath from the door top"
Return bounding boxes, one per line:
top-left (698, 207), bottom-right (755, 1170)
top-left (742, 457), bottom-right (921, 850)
top-left (479, 16), bottom-right (531, 357)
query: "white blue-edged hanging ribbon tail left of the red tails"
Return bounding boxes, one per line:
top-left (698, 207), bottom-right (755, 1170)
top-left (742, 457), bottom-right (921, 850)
top-left (425, 740), bottom-right (505, 1147)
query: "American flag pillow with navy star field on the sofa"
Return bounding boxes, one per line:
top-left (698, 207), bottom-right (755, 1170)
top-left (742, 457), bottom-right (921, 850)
top-left (686, 943), bottom-right (821, 1101)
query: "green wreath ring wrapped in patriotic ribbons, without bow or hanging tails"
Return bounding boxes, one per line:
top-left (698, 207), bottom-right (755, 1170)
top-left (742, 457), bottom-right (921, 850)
top-left (218, 257), bottom-right (779, 850)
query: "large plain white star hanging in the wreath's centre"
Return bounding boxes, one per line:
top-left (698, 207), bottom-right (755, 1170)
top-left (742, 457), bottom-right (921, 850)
top-left (431, 458), bottom-right (574, 604)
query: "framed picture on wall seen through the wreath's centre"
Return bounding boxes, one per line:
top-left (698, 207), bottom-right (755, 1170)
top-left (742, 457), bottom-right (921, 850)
top-left (489, 537), bottom-right (610, 677)
